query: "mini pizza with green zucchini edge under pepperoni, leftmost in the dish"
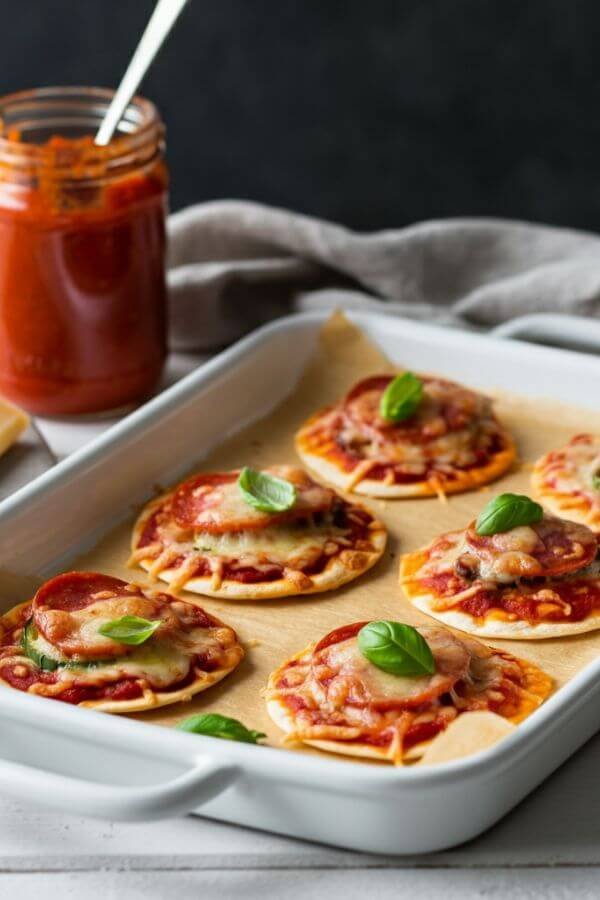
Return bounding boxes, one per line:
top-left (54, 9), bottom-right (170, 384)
top-left (0, 572), bottom-right (244, 713)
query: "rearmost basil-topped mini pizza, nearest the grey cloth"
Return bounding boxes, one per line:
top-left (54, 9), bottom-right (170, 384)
top-left (296, 373), bottom-right (515, 497)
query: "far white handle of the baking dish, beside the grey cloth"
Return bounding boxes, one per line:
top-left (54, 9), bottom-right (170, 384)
top-left (490, 313), bottom-right (600, 353)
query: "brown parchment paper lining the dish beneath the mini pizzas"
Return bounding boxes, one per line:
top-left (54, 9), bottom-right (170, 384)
top-left (3, 314), bottom-right (600, 760)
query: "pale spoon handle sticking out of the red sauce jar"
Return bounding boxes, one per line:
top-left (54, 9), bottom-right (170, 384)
top-left (95, 0), bottom-right (187, 146)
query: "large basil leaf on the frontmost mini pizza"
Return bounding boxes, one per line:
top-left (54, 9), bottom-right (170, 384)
top-left (358, 622), bottom-right (435, 678)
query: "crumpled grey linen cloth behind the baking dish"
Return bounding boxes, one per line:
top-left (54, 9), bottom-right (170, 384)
top-left (168, 200), bottom-right (600, 350)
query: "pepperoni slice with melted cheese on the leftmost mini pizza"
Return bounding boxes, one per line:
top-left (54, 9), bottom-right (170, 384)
top-left (32, 572), bottom-right (179, 660)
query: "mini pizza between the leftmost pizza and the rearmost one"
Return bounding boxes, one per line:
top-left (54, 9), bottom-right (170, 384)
top-left (131, 466), bottom-right (386, 600)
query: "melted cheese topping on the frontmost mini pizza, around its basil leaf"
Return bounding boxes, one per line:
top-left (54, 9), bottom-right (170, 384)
top-left (268, 626), bottom-right (523, 762)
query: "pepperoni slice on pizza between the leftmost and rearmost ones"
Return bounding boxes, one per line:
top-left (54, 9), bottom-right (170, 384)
top-left (170, 466), bottom-right (335, 534)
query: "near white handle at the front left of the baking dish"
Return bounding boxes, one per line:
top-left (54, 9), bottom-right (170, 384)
top-left (0, 757), bottom-right (238, 822)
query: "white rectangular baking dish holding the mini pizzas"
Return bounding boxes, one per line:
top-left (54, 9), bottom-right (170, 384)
top-left (0, 314), bottom-right (600, 853)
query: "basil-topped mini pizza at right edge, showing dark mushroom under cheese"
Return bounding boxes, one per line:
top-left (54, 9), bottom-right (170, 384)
top-left (400, 494), bottom-right (600, 639)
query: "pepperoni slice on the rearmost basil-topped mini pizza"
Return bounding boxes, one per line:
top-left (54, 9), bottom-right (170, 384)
top-left (344, 375), bottom-right (485, 442)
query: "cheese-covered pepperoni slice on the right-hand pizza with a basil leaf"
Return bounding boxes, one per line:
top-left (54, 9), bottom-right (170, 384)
top-left (459, 516), bottom-right (598, 581)
